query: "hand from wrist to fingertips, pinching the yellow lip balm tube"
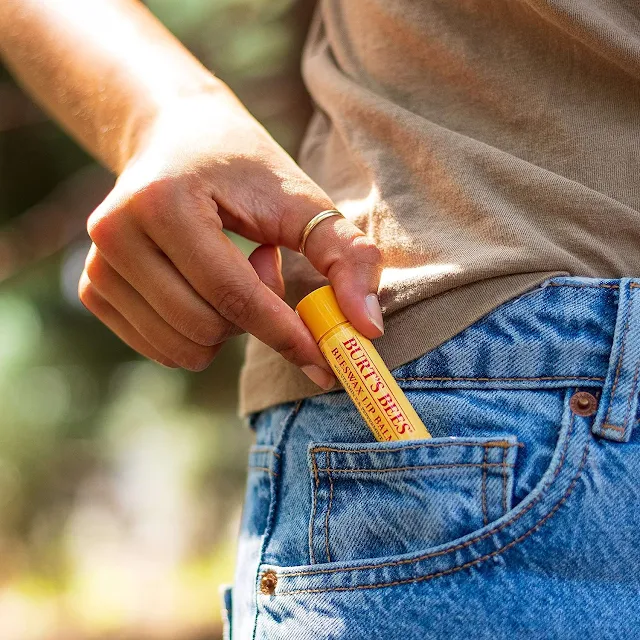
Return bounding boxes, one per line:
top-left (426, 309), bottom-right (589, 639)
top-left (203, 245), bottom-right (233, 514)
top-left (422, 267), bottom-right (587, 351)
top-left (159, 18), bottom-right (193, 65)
top-left (79, 89), bottom-right (382, 389)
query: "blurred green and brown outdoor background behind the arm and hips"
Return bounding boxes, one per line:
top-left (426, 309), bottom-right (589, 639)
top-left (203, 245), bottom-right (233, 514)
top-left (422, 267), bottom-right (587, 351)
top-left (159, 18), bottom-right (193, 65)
top-left (0, 0), bottom-right (313, 640)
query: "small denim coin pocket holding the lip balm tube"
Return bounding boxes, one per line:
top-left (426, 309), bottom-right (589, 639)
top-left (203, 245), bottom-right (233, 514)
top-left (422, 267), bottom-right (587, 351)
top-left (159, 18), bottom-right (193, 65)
top-left (309, 436), bottom-right (518, 564)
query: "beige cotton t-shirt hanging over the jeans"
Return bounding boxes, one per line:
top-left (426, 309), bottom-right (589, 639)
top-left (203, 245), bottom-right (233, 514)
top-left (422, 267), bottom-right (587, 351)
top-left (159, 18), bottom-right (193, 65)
top-left (240, 0), bottom-right (640, 414)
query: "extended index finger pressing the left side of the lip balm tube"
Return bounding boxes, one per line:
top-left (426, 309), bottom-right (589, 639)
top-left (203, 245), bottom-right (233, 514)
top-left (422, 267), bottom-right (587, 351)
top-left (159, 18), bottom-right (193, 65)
top-left (145, 211), bottom-right (335, 389)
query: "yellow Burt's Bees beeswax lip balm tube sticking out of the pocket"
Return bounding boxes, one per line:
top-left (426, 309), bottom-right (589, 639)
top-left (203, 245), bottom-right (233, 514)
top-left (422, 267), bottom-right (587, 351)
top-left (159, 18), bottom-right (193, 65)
top-left (296, 286), bottom-right (431, 441)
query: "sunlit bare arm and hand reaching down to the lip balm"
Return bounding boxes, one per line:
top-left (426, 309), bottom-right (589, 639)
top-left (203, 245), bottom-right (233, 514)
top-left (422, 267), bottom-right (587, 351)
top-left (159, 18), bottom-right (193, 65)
top-left (0, 0), bottom-right (382, 389)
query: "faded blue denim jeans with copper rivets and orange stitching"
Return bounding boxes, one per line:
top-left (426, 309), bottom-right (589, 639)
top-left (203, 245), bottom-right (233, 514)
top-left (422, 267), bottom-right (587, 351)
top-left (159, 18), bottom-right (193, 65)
top-left (225, 278), bottom-right (640, 640)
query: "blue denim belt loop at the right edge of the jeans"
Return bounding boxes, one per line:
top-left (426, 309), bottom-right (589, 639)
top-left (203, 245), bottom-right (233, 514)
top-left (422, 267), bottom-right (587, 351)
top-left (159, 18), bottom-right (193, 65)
top-left (592, 278), bottom-right (640, 442)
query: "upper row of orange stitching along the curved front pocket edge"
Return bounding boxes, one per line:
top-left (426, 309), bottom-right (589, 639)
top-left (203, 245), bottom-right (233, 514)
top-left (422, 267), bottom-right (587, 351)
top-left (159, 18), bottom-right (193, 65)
top-left (278, 413), bottom-right (576, 593)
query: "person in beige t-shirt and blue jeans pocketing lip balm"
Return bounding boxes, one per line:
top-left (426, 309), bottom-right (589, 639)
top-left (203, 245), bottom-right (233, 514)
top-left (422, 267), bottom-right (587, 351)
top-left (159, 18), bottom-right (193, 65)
top-left (0, 0), bottom-right (640, 640)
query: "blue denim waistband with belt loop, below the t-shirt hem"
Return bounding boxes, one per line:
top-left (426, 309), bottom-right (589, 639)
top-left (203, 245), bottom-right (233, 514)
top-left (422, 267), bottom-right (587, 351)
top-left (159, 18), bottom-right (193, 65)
top-left (393, 277), bottom-right (640, 442)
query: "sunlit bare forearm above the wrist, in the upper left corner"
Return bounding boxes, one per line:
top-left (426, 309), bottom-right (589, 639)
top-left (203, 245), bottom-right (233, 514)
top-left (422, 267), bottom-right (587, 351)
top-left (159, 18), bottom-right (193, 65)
top-left (0, 0), bottom-right (228, 173)
